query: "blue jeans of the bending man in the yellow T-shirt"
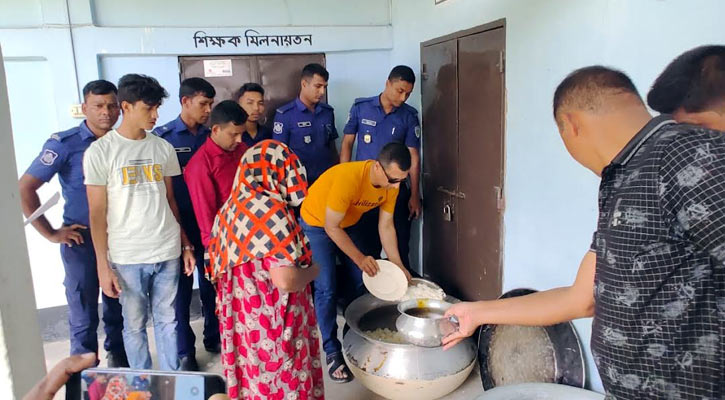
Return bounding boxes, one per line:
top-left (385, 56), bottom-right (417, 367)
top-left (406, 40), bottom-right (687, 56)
top-left (300, 218), bottom-right (367, 356)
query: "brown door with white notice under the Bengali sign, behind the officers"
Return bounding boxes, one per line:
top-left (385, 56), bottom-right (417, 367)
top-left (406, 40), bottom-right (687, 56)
top-left (179, 53), bottom-right (327, 128)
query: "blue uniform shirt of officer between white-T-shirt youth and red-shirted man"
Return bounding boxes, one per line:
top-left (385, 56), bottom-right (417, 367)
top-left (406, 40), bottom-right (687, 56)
top-left (153, 115), bottom-right (211, 220)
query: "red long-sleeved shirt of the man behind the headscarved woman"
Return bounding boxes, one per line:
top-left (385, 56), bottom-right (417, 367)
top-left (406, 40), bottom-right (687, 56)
top-left (184, 137), bottom-right (248, 247)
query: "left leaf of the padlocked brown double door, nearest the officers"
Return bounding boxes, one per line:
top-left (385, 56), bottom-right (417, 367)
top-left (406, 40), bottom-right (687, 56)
top-left (421, 40), bottom-right (458, 292)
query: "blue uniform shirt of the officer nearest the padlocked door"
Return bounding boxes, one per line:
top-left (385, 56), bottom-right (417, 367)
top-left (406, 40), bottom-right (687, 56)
top-left (343, 95), bottom-right (420, 161)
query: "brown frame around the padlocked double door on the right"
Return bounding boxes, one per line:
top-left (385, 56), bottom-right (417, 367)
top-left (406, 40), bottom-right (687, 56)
top-left (419, 18), bottom-right (508, 300)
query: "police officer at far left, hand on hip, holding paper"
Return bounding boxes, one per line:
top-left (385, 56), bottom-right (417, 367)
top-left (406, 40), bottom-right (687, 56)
top-left (19, 80), bottom-right (128, 367)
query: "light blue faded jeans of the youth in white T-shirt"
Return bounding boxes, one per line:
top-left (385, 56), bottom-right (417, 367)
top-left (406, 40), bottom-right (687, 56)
top-left (111, 258), bottom-right (181, 371)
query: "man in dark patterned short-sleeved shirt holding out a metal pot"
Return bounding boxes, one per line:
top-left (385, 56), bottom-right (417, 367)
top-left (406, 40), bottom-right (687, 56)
top-left (444, 66), bottom-right (725, 400)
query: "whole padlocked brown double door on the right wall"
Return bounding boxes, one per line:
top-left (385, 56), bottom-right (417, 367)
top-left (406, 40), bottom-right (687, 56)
top-left (421, 21), bottom-right (505, 300)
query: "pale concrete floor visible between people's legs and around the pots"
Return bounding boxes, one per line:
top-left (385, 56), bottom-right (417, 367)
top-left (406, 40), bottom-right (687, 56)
top-left (43, 317), bottom-right (483, 400)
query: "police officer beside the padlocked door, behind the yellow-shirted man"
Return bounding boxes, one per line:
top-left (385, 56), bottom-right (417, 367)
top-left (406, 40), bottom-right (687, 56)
top-left (340, 65), bottom-right (421, 276)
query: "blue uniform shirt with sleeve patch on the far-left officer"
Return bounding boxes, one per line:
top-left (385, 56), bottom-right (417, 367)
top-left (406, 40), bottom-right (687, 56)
top-left (25, 121), bottom-right (96, 226)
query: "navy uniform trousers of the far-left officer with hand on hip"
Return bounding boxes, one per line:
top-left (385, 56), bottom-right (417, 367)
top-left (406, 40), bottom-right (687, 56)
top-left (60, 229), bottom-right (124, 354)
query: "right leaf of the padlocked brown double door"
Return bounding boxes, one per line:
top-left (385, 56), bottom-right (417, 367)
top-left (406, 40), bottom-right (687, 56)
top-left (454, 28), bottom-right (504, 299)
